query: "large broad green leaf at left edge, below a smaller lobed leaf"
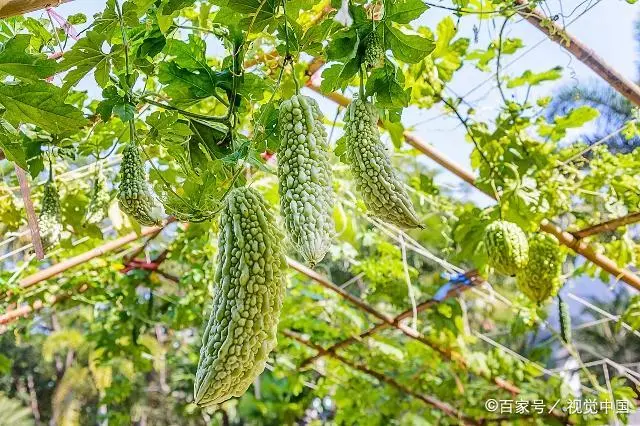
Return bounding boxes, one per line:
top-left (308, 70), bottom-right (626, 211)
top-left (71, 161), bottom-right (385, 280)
top-left (0, 82), bottom-right (89, 134)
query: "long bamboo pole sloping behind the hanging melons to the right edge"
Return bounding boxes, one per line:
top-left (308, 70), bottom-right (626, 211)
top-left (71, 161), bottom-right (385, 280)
top-left (307, 83), bottom-right (640, 290)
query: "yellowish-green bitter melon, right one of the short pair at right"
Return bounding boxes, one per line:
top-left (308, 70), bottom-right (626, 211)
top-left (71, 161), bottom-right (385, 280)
top-left (516, 232), bottom-right (564, 303)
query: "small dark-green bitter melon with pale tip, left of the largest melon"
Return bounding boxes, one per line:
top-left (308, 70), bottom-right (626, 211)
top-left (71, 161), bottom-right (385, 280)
top-left (118, 143), bottom-right (164, 226)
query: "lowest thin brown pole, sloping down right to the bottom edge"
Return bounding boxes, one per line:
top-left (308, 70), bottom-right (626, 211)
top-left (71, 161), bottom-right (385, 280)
top-left (282, 330), bottom-right (482, 425)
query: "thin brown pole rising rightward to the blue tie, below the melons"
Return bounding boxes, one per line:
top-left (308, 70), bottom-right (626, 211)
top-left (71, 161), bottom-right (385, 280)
top-left (300, 271), bottom-right (484, 368)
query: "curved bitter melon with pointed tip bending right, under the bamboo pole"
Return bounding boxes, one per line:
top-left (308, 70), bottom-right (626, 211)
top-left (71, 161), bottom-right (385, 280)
top-left (344, 98), bottom-right (421, 228)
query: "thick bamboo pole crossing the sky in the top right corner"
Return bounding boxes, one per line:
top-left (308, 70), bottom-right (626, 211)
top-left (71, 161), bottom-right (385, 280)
top-left (516, 0), bottom-right (640, 106)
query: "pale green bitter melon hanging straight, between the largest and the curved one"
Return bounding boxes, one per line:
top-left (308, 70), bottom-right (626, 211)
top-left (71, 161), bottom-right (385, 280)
top-left (278, 95), bottom-right (335, 266)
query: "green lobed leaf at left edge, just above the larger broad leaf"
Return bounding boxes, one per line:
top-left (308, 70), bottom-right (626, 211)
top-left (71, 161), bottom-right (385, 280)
top-left (0, 34), bottom-right (56, 81)
